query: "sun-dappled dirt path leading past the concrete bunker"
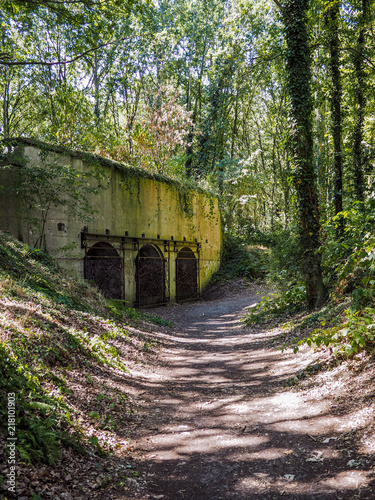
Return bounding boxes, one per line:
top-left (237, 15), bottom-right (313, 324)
top-left (122, 289), bottom-right (375, 500)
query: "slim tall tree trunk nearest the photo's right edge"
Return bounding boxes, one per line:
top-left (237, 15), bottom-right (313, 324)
top-left (353, 0), bottom-right (368, 201)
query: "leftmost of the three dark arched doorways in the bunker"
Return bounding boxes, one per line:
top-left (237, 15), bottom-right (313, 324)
top-left (84, 241), bottom-right (123, 299)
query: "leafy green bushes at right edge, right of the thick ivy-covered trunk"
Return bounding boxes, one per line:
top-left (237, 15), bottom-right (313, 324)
top-left (284, 198), bottom-right (375, 356)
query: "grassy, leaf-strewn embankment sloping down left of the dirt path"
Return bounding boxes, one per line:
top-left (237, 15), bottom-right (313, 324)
top-left (0, 232), bottom-right (167, 465)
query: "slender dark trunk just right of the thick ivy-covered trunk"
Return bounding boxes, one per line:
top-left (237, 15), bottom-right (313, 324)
top-left (326, 0), bottom-right (344, 238)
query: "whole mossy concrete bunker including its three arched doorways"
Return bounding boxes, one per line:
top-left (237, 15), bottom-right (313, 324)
top-left (0, 138), bottom-right (222, 307)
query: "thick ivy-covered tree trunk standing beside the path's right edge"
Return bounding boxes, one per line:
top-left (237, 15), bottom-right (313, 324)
top-left (283, 0), bottom-right (326, 309)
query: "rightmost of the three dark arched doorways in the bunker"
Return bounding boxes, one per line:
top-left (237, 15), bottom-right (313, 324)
top-left (176, 247), bottom-right (198, 302)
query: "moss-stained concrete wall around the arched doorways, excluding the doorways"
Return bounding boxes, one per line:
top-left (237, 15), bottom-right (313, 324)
top-left (0, 139), bottom-right (222, 305)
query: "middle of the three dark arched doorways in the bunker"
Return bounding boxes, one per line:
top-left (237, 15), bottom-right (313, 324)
top-left (135, 244), bottom-right (165, 306)
